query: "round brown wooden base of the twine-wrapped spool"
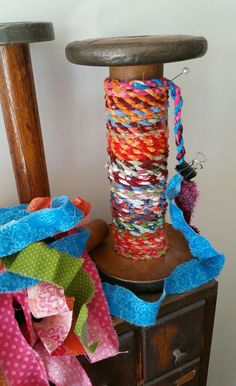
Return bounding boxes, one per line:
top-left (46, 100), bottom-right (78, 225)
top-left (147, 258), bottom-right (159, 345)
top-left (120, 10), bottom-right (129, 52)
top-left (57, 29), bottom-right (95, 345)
top-left (90, 224), bottom-right (191, 293)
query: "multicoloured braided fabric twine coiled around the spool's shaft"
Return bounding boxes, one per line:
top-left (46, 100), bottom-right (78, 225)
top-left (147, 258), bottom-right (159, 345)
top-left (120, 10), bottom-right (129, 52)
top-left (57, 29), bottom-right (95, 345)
top-left (105, 78), bottom-right (172, 259)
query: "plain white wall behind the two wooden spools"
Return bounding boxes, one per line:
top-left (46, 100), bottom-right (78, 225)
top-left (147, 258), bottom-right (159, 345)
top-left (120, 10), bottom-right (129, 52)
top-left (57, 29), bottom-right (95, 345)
top-left (0, 0), bottom-right (236, 386)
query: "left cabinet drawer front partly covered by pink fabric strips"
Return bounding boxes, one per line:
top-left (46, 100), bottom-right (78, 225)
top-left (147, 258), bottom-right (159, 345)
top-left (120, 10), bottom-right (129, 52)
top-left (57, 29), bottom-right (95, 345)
top-left (80, 331), bottom-right (137, 386)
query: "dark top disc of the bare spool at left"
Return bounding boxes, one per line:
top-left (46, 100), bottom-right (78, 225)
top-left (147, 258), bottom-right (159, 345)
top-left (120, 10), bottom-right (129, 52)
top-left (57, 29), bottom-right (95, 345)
top-left (0, 21), bottom-right (55, 45)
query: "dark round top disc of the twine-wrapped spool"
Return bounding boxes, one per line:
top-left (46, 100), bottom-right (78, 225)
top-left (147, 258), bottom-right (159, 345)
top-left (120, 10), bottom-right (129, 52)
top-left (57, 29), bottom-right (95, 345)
top-left (66, 35), bottom-right (207, 67)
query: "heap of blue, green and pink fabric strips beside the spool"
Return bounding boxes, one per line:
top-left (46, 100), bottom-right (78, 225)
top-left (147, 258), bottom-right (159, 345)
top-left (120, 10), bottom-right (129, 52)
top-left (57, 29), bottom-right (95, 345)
top-left (0, 197), bottom-right (118, 386)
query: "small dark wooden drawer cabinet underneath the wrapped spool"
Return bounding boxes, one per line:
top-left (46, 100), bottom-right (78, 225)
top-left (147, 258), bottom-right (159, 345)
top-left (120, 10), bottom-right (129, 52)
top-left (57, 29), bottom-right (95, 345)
top-left (81, 281), bottom-right (217, 386)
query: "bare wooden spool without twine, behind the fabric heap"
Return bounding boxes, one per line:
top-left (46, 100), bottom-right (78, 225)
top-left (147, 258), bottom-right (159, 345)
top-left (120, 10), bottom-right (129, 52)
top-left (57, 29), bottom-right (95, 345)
top-left (0, 22), bottom-right (54, 203)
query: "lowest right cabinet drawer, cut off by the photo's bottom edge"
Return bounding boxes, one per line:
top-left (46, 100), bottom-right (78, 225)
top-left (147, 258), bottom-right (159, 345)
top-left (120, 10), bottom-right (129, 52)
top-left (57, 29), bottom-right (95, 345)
top-left (144, 358), bottom-right (201, 386)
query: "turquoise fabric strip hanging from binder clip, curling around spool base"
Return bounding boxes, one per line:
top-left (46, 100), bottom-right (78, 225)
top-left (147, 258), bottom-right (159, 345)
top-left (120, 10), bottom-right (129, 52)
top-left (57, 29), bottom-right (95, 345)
top-left (103, 174), bottom-right (225, 327)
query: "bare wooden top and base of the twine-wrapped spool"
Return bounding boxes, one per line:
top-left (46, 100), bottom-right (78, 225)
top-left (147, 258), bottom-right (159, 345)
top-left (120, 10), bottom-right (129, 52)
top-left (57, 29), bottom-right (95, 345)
top-left (66, 35), bottom-right (207, 293)
